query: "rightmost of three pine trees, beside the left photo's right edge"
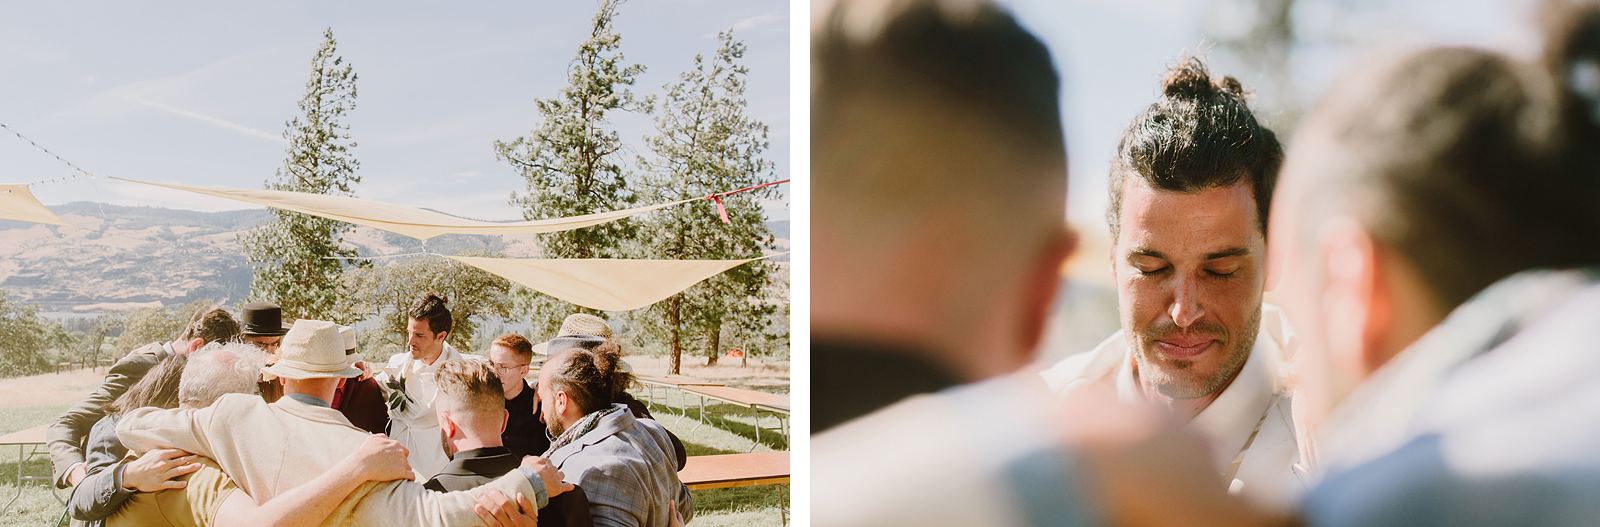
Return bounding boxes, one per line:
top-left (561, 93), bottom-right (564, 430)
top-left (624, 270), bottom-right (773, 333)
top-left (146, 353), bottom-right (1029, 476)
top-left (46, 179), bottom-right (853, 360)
top-left (643, 30), bottom-right (776, 373)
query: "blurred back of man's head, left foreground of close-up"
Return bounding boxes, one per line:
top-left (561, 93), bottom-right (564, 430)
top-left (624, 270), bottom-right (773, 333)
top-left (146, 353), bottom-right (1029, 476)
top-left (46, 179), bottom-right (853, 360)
top-left (811, 0), bottom-right (1074, 383)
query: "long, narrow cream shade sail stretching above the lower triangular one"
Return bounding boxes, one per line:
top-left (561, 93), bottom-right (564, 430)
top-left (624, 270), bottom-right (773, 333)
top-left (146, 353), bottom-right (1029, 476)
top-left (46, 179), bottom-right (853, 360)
top-left (112, 178), bottom-right (691, 240)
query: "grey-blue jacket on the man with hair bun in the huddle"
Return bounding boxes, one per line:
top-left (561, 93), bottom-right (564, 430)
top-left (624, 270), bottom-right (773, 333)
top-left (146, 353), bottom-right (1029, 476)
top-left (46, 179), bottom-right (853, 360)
top-left (549, 404), bottom-right (694, 527)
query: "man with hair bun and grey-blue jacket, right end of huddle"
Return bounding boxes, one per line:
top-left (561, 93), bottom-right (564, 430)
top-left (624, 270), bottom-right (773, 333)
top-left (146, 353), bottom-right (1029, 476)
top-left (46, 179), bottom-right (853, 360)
top-left (538, 343), bottom-right (694, 525)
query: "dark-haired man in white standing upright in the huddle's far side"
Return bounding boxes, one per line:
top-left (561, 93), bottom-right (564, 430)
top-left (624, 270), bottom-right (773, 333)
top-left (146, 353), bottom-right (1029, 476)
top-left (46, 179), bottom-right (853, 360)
top-left (379, 293), bottom-right (461, 481)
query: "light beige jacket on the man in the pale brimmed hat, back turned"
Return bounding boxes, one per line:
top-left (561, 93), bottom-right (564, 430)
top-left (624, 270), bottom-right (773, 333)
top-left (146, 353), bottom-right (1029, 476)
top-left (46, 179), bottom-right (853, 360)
top-left (117, 394), bottom-right (534, 525)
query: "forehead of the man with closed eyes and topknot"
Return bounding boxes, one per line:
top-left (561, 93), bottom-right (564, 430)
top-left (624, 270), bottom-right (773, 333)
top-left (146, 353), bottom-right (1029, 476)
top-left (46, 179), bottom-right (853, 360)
top-left (1117, 179), bottom-right (1264, 259)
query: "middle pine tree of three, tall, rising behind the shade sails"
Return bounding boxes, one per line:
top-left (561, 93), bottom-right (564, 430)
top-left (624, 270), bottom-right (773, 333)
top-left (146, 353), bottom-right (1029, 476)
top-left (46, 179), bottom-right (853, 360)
top-left (494, 0), bottom-right (651, 336)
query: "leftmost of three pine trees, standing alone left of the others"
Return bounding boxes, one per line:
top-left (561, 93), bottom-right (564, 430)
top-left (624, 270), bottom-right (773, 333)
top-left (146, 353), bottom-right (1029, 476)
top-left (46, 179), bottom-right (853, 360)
top-left (240, 27), bottom-right (362, 324)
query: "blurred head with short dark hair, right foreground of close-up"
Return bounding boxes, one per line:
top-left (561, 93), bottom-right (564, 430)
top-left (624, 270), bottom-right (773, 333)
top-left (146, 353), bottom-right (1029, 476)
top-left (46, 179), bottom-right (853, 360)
top-left (1270, 11), bottom-right (1600, 421)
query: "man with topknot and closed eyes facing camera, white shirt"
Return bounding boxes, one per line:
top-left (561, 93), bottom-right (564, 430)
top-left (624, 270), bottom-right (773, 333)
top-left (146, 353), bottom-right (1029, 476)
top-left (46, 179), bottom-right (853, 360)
top-left (1043, 58), bottom-right (1304, 508)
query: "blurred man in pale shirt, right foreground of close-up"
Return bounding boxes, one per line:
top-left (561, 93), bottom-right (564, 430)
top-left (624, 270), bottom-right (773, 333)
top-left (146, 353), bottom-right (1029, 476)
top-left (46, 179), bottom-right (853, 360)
top-left (1091, 2), bottom-right (1600, 525)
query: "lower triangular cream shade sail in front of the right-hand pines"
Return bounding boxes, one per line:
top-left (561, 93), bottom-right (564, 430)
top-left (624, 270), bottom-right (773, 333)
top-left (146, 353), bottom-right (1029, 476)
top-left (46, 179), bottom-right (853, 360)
top-left (450, 256), bottom-right (780, 311)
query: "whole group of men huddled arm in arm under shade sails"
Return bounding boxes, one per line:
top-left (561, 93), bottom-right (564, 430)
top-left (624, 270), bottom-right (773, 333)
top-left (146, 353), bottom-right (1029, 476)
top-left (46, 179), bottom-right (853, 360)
top-left (48, 293), bottom-right (693, 525)
